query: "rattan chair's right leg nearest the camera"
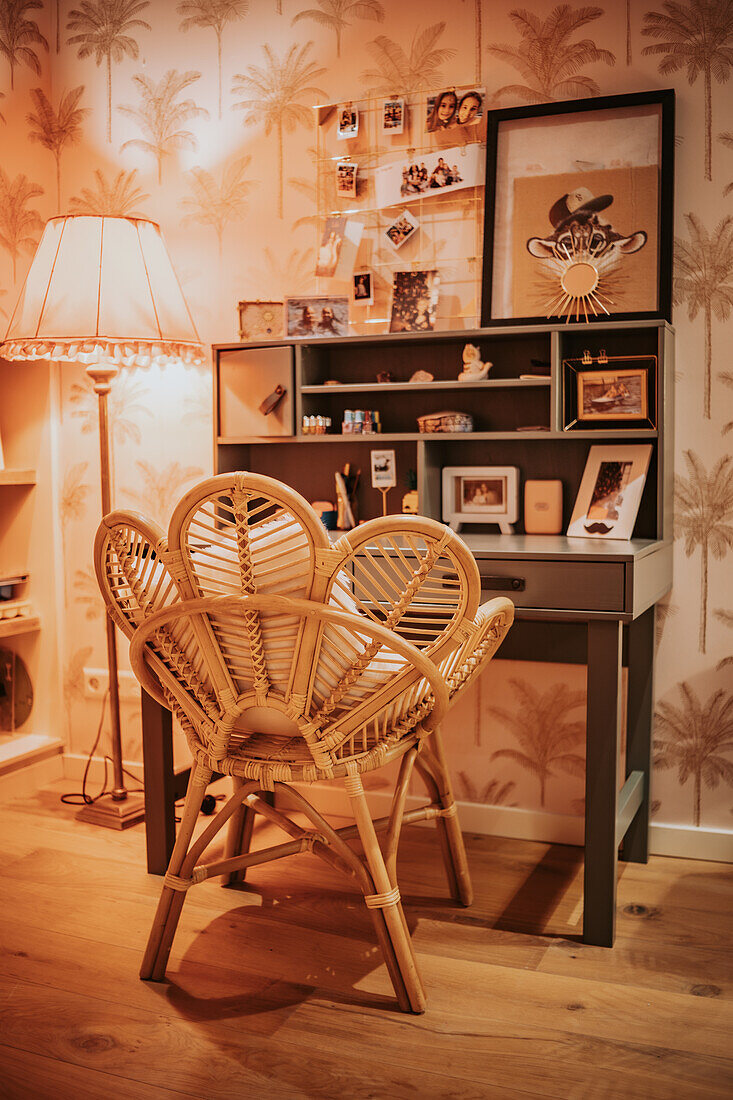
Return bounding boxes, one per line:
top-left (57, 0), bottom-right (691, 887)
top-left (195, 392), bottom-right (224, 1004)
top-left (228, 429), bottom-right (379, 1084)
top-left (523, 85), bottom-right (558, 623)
top-left (344, 776), bottom-right (426, 1012)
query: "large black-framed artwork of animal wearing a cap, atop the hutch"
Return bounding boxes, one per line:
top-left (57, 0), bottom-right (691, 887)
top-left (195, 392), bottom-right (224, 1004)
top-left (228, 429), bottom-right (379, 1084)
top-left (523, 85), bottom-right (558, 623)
top-left (481, 91), bottom-right (675, 325)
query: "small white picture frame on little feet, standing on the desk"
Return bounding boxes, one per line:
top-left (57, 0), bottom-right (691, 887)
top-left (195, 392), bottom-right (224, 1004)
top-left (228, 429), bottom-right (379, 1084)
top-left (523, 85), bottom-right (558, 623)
top-left (442, 466), bottom-right (519, 535)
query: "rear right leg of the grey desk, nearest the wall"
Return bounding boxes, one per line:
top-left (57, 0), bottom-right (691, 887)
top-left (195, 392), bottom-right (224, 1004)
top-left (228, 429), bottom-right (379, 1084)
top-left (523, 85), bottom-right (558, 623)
top-left (621, 607), bottom-right (654, 864)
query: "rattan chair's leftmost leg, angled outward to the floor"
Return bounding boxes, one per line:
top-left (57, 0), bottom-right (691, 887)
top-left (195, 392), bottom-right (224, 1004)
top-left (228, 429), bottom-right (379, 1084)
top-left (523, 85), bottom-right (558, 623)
top-left (140, 765), bottom-right (212, 981)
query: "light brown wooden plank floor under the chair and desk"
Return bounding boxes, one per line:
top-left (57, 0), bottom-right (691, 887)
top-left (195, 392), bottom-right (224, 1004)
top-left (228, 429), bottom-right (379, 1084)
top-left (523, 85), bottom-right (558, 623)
top-left (0, 783), bottom-right (733, 1100)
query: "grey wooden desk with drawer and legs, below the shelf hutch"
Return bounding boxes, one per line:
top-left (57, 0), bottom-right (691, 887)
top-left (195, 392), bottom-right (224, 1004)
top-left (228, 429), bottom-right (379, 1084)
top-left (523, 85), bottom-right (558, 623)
top-left (137, 535), bottom-right (672, 947)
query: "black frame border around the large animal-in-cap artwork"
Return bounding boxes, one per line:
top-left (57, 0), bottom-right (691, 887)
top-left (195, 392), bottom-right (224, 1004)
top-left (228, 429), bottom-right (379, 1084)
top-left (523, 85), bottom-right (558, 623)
top-left (481, 89), bottom-right (675, 326)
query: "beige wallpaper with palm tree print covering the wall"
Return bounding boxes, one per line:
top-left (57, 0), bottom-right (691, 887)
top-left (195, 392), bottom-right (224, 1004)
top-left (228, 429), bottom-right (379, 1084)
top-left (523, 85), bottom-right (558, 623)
top-left (0, 0), bottom-right (733, 844)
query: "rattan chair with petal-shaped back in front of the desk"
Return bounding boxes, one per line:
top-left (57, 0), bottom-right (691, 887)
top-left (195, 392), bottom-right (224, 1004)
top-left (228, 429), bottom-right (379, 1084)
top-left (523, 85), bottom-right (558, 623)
top-left (95, 473), bottom-right (514, 1012)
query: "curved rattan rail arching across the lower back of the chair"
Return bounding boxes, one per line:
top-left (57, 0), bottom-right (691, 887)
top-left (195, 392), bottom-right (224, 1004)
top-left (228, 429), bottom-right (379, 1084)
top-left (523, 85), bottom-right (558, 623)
top-left (130, 595), bottom-right (449, 728)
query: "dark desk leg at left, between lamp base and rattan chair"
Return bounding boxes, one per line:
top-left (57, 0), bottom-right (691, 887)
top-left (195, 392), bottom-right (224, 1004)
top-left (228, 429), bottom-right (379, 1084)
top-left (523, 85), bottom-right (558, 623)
top-left (142, 691), bottom-right (176, 875)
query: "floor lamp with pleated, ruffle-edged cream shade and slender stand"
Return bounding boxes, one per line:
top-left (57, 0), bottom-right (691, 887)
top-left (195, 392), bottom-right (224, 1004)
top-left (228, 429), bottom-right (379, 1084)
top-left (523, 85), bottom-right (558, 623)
top-left (0, 215), bottom-right (204, 828)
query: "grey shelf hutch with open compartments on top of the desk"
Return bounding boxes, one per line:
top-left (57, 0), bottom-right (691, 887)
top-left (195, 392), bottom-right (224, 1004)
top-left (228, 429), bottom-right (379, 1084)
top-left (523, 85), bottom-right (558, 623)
top-left (214, 320), bottom-right (674, 539)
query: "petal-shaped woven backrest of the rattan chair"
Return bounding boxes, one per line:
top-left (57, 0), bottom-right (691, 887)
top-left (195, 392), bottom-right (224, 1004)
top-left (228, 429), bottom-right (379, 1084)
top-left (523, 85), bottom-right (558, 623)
top-left (96, 473), bottom-right (480, 767)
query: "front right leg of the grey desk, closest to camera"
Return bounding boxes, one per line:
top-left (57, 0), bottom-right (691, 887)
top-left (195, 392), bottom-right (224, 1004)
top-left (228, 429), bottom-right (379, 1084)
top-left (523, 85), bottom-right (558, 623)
top-left (583, 619), bottom-right (622, 947)
